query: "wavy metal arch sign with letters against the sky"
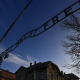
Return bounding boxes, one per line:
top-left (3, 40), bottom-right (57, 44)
top-left (0, 0), bottom-right (80, 57)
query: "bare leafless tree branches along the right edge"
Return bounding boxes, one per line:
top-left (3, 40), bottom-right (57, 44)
top-left (60, 14), bottom-right (80, 74)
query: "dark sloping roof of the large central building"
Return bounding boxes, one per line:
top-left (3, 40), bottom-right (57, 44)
top-left (15, 61), bottom-right (70, 79)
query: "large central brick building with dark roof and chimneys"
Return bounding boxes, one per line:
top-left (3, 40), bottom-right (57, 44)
top-left (15, 61), bottom-right (71, 80)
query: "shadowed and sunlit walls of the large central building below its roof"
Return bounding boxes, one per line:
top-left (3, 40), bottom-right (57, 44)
top-left (16, 64), bottom-right (69, 80)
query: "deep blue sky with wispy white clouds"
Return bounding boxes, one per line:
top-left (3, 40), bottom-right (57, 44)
top-left (0, 0), bottom-right (80, 77)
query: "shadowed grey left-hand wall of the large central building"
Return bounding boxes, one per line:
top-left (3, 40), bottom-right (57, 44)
top-left (15, 68), bottom-right (47, 80)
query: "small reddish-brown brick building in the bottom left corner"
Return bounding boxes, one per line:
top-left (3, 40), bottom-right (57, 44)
top-left (0, 69), bottom-right (16, 80)
